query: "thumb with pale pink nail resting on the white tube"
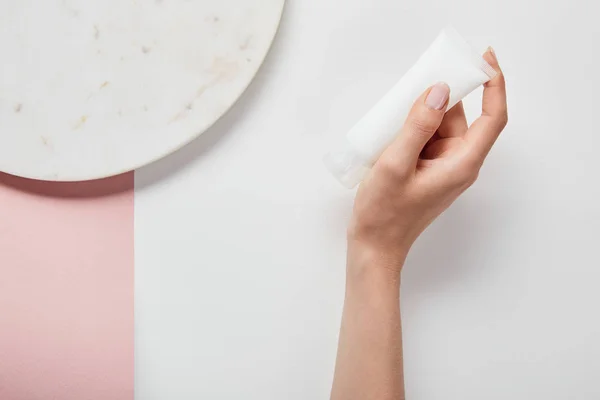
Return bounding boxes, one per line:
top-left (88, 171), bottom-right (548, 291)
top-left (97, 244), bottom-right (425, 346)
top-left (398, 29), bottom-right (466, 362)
top-left (384, 83), bottom-right (450, 170)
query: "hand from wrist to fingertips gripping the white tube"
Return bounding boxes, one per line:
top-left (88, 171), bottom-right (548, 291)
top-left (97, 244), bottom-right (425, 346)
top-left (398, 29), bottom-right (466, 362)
top-left (348, 48), bottom-right (508, 273)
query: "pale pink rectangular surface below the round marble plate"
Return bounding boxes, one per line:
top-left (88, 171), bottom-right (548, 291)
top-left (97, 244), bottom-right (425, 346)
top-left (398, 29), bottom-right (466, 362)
top-left (0, 174), bottom-right (134, 400)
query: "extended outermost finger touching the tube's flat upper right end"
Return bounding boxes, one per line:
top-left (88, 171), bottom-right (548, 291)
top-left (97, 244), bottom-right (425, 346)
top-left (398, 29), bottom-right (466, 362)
top-left (465, 47), bottom-right (508, 162)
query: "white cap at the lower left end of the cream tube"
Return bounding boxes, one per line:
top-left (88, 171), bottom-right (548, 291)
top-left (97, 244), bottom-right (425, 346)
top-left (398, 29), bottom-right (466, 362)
top-left (323, 144), bottom-right (370, 189)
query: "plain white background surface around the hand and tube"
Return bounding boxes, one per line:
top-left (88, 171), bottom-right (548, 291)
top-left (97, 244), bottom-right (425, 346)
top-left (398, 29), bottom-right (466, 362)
top-left (135, 0), bottom-right (600, 400)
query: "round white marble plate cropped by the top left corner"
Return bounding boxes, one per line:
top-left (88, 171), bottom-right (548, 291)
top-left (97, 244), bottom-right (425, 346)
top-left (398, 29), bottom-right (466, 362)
top-left (0, 0), bottom-right (285, 181)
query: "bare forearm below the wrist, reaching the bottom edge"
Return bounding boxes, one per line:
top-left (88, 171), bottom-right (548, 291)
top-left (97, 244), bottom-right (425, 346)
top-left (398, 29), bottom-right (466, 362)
top-left (331, 250), bottom-right (404, 400)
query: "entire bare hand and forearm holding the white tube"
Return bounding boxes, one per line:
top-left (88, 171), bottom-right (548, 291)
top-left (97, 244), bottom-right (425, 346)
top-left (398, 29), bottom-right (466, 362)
top-left (331, 48), bottom-right (508, 400)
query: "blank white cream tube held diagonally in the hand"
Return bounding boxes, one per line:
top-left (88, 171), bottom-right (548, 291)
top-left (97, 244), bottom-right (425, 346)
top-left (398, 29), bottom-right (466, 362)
top-left (325, 28), bottom-right (496, 188)
